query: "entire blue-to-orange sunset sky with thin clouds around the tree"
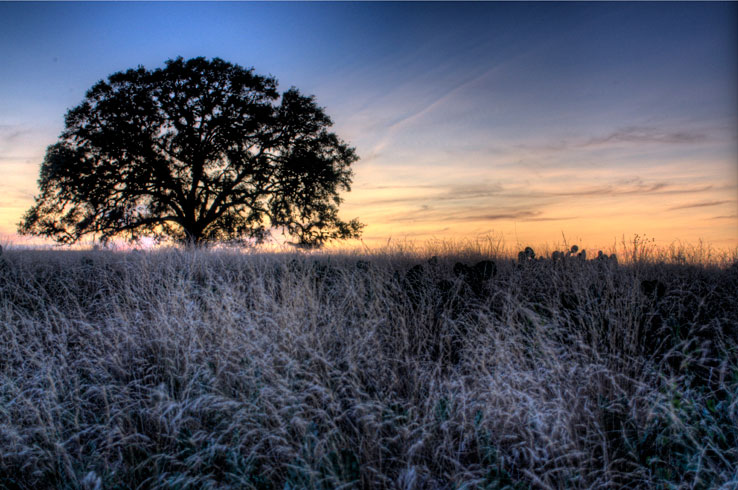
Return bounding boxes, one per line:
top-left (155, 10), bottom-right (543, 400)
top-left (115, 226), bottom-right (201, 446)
top-left (0, 2), bottom-right (738, 248)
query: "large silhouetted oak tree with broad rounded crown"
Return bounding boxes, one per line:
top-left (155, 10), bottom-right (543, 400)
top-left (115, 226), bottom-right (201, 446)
top-left (19, 58), bottom-right (363, 246)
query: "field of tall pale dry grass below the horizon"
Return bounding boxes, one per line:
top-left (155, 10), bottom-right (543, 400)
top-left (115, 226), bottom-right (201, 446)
top-left (0, 247), bottom-right (738, 489)
